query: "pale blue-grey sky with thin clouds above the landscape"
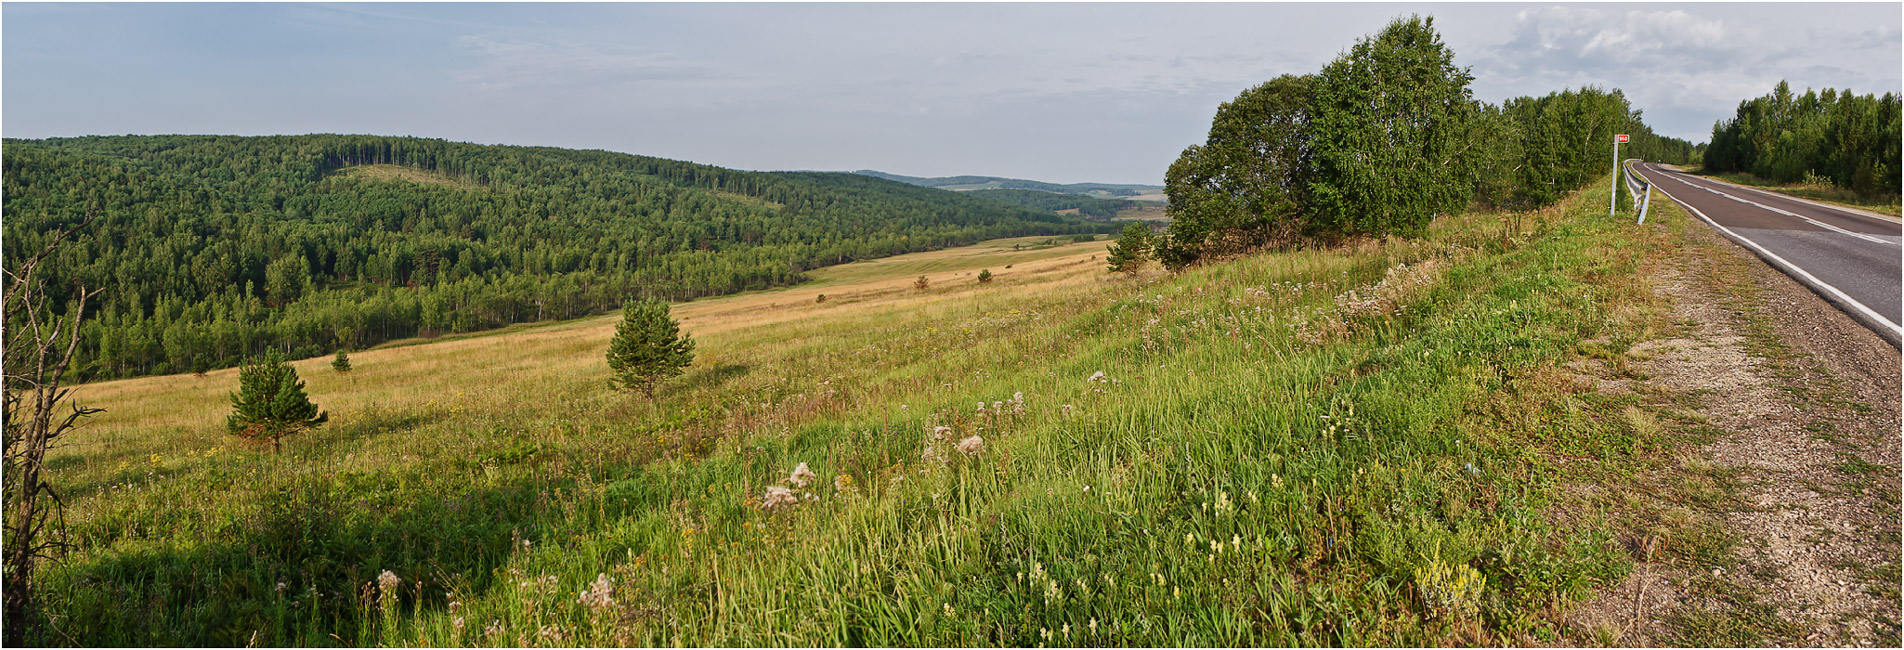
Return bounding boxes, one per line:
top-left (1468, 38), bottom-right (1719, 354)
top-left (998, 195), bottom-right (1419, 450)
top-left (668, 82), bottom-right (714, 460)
top-left (0, 2), bottom-right (1904, 185)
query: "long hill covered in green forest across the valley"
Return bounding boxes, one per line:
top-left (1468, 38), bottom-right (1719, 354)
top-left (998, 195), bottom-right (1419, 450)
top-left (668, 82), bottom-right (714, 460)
top-left (4, 135), bottom-right (1106, 377)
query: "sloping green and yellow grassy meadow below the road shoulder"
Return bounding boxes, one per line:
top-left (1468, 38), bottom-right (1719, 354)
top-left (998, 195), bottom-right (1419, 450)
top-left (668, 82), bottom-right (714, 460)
top-left (44, 185), bottom-right (1681, 646)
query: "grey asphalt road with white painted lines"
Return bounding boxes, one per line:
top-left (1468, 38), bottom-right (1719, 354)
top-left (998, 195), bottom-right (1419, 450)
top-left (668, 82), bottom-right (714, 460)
top-left (1630, 162), bottom-right (1904, 343)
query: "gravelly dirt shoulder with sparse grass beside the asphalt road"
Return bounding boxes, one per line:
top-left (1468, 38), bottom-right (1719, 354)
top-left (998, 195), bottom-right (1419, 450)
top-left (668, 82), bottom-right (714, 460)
top-left (1569, 219), bottom-right (1900, 646)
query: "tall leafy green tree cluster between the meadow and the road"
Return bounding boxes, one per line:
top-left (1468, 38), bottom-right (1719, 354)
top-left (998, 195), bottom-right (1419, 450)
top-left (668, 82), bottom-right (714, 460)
top-left (1158, 17), bottom-right (1696, 267)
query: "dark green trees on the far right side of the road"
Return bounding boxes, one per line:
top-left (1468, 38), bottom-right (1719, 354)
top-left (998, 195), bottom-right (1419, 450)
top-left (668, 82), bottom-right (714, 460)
top-left (1704, 82), bottom-right (1904, 196)
